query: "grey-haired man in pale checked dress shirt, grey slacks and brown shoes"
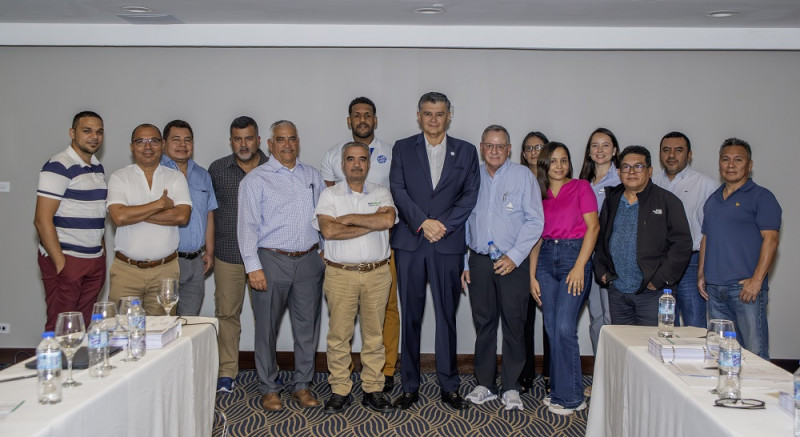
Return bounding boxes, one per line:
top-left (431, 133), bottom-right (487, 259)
top-left (237, 120), bottom-right (325, 411)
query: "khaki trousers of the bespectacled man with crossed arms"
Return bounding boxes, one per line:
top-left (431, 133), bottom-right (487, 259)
top-left (108, 258), bottom-right (181, 316)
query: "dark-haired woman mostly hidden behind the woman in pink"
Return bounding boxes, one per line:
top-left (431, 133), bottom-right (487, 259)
top-left (519, 131), bottom-right (550, 393)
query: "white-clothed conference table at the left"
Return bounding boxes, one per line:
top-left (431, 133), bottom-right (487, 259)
top-left (0, 317), bottom-right (219, 437)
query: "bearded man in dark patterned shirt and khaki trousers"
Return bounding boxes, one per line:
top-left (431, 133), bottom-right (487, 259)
top-left (208, 115), bottom-right (268, 393)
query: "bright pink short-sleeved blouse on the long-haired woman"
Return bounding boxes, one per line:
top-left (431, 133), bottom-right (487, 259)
top-left (542, 179), bottom-right (597, 240)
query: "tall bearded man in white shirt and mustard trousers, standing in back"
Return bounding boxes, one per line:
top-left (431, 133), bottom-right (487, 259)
top-left (320, 97), bottom-right (400, 392)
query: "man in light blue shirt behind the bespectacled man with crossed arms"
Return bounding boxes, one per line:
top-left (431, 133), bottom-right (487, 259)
top-left (161, 120), bottom-right (217, 316)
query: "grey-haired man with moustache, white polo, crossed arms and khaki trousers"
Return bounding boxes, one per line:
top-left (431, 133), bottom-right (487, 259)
top-left (312, 142), bottom-right (397, 414)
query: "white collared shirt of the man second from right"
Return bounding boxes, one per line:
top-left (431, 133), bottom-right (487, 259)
top-left (653, 166), bottom-right (720, 251)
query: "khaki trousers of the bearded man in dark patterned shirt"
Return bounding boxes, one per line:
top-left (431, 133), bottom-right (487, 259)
top-left (214, 258), bottom-right (247, 378)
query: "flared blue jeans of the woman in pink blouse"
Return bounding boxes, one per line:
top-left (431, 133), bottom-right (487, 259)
top-left (536, 239), bottom-right (592, 408)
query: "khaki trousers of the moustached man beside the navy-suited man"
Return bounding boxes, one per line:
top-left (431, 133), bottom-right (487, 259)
top-left (323, 265), bottom-right (392, 396)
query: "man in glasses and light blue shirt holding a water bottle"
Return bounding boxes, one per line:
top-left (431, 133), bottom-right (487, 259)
top-left (461, 125), bottom-right (544, 410)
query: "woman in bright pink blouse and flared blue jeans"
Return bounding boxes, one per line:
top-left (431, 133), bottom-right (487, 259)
top-left (530, 142), bottom-right (600, 415)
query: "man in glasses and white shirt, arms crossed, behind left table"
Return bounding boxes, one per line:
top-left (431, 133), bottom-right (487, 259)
top-left (106, 123), bottom-right (192, 315)
